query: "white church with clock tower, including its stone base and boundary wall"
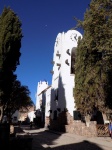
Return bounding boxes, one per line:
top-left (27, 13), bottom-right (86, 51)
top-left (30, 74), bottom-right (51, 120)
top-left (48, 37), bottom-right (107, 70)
top-left (36, 29), bottom-right (109, 137)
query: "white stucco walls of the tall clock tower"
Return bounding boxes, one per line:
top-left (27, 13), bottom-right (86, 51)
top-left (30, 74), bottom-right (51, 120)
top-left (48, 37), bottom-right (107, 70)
top-left (51, 30), bottom-right (82, 117)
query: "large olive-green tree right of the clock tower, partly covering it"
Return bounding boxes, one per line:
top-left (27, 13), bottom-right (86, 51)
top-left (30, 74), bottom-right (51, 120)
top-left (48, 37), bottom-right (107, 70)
top-left (74, 0), bottom-right (112, 114)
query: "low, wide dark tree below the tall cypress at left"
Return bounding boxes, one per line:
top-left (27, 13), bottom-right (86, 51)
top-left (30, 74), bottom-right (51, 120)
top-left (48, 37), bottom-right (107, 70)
top-left (5, 80), bottom-right (34, 118)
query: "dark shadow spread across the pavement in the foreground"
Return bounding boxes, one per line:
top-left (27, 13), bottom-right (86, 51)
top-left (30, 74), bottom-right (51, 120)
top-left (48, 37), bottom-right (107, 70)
top-left (10, 125), bottom-right (103, 150)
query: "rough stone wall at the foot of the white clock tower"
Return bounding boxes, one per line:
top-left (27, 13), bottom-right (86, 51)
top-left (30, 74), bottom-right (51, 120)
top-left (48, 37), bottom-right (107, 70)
top-left (50, 111), bottom-right (97, 137)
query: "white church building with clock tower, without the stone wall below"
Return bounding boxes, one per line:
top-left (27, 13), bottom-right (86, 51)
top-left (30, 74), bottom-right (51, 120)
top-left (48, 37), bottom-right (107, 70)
top-left (36, 30), bottom-right (82, 127)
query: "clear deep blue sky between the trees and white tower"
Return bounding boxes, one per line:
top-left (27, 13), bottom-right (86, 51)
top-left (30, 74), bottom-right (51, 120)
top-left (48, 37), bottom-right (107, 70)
top-left (0, 0), bottom-right (91, 103)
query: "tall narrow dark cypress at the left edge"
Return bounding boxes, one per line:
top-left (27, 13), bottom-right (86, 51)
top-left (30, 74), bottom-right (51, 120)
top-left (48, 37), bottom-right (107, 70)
top-left (0, 7), bottom-right (22, 116)
